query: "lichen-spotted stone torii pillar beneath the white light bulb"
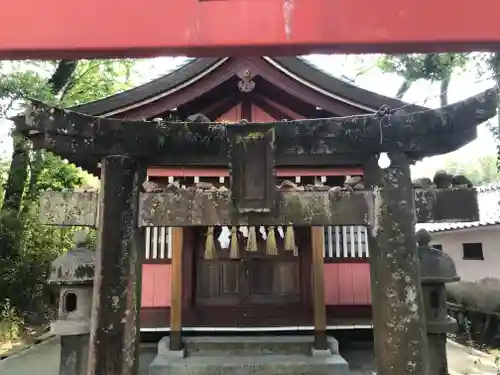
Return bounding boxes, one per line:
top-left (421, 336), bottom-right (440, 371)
top-left (365, 153), bottom-right (429, 375)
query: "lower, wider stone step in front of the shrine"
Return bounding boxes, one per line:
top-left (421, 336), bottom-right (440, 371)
top-left (149, 354), bottom-right (349, 375)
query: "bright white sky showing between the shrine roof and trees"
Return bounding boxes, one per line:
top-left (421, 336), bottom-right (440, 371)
top-left (0, 55), bottom-right (496, 177)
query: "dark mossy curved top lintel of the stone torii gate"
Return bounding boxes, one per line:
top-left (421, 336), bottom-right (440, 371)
top-left (16, 87), bottom-right (498, 168)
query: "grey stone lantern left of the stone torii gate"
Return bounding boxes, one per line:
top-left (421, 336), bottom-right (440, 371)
top-left (49, 232), bottom-right (95, 375)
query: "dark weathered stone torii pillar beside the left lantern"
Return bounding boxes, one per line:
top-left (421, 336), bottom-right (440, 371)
top-left (88, 156), bottom-right (144, 375)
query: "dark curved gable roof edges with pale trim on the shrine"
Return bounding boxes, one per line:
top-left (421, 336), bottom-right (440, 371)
top-left (71, 57), bottom-right (426, 117)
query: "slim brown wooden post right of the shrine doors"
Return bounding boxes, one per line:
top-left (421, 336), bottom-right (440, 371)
top-left (311, 226), bottom-right (328, 350)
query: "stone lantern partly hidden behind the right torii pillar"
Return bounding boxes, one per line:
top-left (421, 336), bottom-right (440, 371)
top-left (416, 229), bottom-right (460, 375)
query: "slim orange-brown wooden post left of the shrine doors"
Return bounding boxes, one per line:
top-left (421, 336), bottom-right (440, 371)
top-left (170, 227), bottom-right (184, 351)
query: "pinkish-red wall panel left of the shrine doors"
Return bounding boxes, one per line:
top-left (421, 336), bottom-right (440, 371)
top-left (141, 264), bottom-right (171, 307)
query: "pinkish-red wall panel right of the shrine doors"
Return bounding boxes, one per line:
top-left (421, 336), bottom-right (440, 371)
top-left (324, 262), bottom-right (372, 306)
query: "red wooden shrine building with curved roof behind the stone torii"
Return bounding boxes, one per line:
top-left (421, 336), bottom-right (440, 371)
top-left (57, 57), bottom-right (430, 331)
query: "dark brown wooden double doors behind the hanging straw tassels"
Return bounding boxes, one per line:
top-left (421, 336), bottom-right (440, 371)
top-left (194, 226), bottom-right (303, 307)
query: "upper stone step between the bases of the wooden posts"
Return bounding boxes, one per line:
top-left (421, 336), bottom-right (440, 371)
top-left (158, 336), bottom-right (338, 357)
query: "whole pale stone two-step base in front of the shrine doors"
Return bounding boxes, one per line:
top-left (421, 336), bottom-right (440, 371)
top-left (149, 336), bottom-right (349, 375)
